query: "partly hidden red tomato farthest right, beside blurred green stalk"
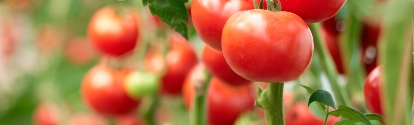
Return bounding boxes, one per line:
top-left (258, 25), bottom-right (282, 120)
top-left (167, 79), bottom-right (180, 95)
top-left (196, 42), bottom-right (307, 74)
top-left (364, 66), bottom-right (383, 115)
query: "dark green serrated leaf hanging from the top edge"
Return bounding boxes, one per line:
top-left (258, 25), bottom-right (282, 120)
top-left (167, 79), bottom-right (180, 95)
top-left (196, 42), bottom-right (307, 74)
top-left (143, 0), bottom-right (188, 39)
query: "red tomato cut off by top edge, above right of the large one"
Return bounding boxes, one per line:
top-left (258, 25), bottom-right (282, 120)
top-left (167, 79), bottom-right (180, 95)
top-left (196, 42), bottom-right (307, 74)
top-left (280, 0), bottom-right (346, 23)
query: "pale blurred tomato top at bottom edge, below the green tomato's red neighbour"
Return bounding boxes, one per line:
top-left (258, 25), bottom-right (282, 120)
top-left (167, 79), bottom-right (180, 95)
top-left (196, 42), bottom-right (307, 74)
top-left (69, 114), bottom-right (108, 125)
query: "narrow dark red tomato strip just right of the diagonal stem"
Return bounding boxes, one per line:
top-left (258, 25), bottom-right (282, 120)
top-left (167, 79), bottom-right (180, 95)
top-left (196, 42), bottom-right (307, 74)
top-left (322, 18), bottom-right (345, 74)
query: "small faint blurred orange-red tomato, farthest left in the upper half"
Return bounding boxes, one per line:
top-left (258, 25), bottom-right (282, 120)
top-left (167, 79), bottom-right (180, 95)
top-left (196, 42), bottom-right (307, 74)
top-left (65, 38), bottom-right (96, 65)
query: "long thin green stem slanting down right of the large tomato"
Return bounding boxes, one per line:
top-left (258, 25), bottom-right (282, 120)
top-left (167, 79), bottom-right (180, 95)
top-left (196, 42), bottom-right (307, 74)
top-left (309, 24), bottom-right (351, 107)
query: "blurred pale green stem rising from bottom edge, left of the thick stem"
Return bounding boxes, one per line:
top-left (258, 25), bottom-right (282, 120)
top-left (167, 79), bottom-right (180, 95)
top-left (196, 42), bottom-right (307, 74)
top-left (190, 70), bottom-right (211, 125)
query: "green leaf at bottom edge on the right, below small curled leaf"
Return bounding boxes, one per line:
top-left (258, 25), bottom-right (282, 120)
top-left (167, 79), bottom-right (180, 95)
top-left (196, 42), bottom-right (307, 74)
top-left (329, 105), bottom-right (371, 125)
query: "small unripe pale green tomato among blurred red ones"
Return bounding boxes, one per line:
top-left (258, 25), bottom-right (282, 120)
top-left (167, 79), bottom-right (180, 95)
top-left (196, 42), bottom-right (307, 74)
top-left (125, 71), bottom-right (159, 98)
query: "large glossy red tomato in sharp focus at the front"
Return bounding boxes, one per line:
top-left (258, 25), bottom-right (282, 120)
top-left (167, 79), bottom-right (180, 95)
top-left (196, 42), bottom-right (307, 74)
top-left (222, 9), bottom-right (313, 82)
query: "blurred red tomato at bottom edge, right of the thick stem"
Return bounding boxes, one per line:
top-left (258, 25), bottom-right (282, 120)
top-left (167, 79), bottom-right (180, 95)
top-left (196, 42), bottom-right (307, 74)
top-left (285, 102), bottom-right (340, 125)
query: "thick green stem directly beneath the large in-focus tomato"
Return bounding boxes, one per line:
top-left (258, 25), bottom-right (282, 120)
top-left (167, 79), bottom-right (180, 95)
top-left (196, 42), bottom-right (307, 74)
top-left (256, 82), bottom-right (285, 125)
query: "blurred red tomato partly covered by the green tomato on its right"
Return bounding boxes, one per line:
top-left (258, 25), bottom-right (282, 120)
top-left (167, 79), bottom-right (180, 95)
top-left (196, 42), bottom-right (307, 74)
top-left (81, 64), bottom-right (140, 116)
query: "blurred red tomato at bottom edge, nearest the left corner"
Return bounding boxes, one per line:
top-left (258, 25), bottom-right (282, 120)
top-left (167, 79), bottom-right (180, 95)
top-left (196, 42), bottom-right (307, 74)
top-left (34, 103), bottom-right (60, 125)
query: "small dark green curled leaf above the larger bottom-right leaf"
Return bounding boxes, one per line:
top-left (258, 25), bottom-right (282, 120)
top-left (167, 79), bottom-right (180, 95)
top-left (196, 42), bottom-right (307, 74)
top-left (308, 89), bottom-right (336, 109)
